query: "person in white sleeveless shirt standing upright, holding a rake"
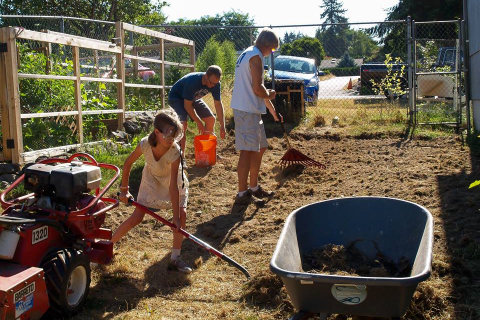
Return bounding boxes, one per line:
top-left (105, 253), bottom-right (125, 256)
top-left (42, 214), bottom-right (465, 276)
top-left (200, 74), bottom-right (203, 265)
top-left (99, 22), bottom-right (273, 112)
top-left (231, 28), bottom-right (283, 206)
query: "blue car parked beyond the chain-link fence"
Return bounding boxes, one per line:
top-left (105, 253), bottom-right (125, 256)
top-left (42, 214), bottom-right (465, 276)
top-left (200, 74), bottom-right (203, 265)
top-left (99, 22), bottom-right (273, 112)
top-left (270, 55), bottom-right (323, 102)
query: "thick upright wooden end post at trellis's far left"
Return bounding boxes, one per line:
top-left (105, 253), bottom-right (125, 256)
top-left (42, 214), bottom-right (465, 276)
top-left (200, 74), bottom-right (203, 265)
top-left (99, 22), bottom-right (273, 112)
top-left (4, 28), bottom-right (23, 164)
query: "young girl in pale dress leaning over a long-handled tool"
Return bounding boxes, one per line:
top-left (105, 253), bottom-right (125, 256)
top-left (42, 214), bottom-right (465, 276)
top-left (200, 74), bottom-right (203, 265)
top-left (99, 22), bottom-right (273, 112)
top-left (112, 109), bottom-right (192, 273)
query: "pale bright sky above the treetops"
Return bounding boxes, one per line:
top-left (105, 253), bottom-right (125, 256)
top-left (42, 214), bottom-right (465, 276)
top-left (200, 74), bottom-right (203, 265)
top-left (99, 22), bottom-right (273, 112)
top-left (163, 0), bottom-right (399, 26)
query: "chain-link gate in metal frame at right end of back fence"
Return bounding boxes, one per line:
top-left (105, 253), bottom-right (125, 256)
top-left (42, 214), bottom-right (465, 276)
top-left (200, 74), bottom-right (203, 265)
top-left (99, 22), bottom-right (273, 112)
top-left (411, 20), bottom-right (470, 132)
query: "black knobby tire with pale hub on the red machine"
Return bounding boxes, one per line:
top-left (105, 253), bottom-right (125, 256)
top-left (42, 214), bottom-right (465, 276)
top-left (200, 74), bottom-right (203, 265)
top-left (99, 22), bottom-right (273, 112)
top-left (41, 249), bottom-right (91, 316)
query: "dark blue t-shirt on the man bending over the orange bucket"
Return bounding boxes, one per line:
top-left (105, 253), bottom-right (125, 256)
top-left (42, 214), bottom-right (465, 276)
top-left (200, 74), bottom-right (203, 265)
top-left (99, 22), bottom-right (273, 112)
top-left (168, 72), bottom-right (220, 101)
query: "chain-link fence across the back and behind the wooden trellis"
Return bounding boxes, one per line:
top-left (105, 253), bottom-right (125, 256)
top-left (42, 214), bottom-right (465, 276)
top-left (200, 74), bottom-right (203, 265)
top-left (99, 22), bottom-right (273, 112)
top-left (0, 16), bottom-right (464, 154)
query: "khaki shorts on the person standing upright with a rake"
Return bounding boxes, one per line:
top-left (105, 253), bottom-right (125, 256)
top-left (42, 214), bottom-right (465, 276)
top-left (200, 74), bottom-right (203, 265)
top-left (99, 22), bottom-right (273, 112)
top-left (233, 109), bottom-right (268, 152)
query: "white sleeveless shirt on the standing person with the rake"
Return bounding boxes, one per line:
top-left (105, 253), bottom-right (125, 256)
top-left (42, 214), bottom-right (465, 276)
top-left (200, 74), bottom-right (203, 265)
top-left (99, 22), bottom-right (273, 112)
top-left (230, 46), bottom-right (267, 114)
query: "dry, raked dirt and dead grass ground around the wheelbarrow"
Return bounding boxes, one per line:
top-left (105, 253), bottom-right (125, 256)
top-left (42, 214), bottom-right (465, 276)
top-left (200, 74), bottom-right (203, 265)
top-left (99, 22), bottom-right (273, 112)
top-left (75, 127), bottom-right (480, 320)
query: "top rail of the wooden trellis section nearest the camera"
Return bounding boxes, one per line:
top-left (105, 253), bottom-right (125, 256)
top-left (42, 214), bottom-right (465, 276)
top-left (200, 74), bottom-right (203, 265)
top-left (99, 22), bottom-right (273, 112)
top-left (13, 28), bottom-right (122, 53)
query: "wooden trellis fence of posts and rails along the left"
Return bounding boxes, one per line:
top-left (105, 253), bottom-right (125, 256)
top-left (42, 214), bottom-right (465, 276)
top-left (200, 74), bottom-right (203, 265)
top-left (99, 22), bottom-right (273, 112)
top-left (0, 22), bottom-right (195, 164)
